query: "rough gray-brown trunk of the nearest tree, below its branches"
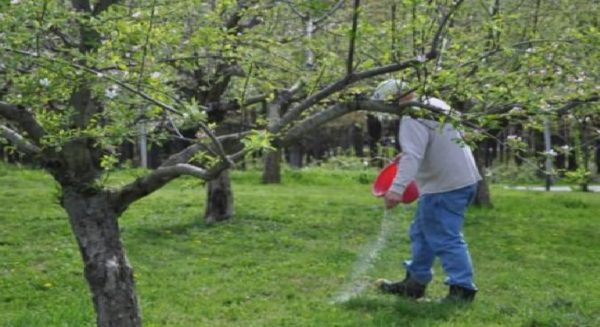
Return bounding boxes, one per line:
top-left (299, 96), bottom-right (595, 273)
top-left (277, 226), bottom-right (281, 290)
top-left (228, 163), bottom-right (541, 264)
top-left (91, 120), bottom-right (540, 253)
top-left (62, 189), bottom-right (142, 327)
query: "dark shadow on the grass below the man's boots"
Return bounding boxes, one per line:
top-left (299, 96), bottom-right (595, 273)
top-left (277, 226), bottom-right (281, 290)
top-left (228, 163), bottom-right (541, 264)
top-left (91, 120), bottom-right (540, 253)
top-left (342, 296), bottom-right (468, 326)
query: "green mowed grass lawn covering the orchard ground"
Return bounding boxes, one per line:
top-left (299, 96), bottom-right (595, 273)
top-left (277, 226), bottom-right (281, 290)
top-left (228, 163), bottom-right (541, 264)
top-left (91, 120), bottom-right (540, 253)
top-left (0, 165), bottom-right (600, 327)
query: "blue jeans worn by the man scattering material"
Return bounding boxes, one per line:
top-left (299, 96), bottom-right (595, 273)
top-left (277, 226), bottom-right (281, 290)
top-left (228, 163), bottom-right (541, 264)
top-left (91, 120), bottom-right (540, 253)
top-left (404, 184), bottom-right (477, 290)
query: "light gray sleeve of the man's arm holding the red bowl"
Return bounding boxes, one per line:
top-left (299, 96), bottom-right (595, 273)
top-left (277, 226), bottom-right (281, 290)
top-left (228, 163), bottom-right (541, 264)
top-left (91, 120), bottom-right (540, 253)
top-left (390, 117), bottom-right (429, 194)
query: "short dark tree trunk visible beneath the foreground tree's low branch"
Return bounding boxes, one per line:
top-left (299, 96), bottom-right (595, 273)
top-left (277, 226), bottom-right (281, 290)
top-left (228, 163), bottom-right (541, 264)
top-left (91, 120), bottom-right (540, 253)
top-left (204, 170), bottom-right (234, 224)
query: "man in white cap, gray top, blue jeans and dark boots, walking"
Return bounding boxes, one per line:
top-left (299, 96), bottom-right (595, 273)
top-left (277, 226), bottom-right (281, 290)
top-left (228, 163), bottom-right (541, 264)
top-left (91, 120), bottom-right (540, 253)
top-left (373, 80), bottom-right (481, 302)
